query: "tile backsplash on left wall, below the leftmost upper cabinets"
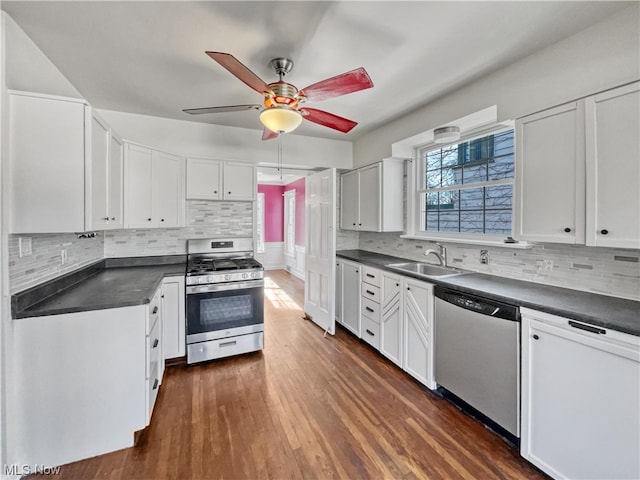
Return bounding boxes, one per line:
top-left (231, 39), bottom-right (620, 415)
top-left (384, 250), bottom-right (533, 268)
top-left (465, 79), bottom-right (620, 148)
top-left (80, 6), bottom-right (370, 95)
top-left (8, 232), bottom-right (104, 294)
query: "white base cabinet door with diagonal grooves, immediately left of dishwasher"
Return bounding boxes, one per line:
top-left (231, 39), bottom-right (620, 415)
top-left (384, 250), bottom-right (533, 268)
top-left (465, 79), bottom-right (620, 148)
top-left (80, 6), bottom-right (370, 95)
top-left (403, 278), bottom-right (435, 389)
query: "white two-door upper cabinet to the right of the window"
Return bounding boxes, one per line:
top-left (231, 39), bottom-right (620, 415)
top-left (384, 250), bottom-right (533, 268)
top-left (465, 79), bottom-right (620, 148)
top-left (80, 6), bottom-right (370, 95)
top-left (515, 82), bottom-right (640, 248)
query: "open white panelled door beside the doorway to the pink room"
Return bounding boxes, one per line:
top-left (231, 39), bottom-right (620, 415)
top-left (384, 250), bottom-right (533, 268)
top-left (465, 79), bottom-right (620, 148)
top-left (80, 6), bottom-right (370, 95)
top-left (304, 168), bottom-right (336, 334)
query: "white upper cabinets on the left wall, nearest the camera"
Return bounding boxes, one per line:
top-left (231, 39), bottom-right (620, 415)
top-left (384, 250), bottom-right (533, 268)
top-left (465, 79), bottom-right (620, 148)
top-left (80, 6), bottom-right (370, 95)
top-left (9, 92), bottom-right (122, 233)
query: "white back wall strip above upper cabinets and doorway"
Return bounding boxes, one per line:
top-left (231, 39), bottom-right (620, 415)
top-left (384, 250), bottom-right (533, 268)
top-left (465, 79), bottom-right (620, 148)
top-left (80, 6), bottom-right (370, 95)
top-left (99, 110), bottom-right (353, 168)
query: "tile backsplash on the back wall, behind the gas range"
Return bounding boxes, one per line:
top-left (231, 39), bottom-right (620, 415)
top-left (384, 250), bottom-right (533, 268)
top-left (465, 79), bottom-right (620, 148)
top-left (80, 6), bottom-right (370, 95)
top-left (104, 201), bottom-right (254, 258)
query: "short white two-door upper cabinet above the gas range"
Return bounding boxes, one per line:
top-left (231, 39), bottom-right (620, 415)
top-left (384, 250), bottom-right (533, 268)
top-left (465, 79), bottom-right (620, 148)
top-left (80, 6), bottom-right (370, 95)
top-left (187, 158), bottom-right (257, 201)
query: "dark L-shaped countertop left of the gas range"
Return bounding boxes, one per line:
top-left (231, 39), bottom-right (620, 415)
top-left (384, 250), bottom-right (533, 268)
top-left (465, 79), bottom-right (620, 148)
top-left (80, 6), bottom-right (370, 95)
top-left (12, 256), bottom-right (185, 319)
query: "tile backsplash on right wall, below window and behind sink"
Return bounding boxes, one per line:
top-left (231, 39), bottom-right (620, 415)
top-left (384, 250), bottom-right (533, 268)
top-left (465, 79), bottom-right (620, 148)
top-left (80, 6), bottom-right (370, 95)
top-left (359, 232), bottom-right (640, 300)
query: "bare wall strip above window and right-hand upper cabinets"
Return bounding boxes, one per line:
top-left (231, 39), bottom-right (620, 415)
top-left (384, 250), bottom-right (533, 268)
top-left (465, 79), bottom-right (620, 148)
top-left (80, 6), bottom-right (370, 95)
top-left (353, 4), bottom-right (640, 167)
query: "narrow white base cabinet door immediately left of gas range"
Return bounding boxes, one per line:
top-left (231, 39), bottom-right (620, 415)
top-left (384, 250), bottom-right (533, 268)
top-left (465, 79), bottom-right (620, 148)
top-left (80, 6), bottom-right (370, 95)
top-left (161, 277), bottom-right (186, 358)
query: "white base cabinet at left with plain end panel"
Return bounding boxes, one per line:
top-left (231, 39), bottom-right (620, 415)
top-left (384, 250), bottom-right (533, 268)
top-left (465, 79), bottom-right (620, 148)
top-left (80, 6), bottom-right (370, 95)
top-left (8, 282), bottom-right (163, 466)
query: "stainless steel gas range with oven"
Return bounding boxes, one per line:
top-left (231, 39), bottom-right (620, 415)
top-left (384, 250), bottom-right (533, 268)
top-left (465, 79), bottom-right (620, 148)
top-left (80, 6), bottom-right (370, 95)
top-left (186, 237), bottom-right (264, 364)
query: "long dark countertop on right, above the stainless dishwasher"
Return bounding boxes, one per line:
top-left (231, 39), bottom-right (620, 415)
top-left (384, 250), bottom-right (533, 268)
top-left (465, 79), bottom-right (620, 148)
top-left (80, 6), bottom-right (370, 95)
top-left (337, 250), bottom-right (640, 336)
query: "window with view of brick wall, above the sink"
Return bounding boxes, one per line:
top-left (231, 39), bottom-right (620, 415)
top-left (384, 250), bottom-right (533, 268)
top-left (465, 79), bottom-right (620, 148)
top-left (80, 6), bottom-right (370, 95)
top-left (416, 129), bottom-right (514, 238)
